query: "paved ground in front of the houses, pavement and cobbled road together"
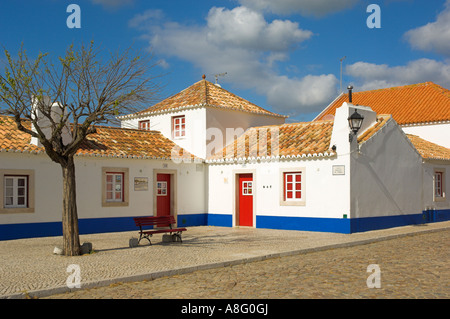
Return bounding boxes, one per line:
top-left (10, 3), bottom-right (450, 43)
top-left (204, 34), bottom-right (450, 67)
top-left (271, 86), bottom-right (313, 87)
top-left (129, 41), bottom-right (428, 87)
top-left (0, 222), bottom-right (450, 299)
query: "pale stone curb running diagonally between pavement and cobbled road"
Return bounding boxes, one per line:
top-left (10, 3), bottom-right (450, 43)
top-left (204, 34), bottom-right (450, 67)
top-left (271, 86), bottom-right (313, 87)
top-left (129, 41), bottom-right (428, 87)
top-left (0, 226), bottom-right (450, 299)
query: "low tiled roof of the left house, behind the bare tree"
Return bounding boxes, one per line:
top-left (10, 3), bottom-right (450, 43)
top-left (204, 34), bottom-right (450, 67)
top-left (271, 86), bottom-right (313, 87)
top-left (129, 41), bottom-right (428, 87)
top-left (0, 116), bottom-right (199, 160)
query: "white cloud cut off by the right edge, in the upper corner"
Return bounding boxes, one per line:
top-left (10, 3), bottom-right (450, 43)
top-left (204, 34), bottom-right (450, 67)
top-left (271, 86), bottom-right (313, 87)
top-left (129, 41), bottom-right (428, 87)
top-left (404, 0), bottom-right (450, 56)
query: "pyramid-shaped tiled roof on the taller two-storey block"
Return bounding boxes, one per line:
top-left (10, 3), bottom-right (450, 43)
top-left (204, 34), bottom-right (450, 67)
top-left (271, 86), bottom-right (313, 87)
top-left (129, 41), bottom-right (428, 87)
top-left (120, 77), bottom-right (287, 119)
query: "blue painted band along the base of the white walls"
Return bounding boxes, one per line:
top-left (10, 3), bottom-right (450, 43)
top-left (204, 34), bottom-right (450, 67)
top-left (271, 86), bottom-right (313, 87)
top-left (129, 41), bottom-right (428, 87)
top-left (0, 209), bottom-right (450, 240)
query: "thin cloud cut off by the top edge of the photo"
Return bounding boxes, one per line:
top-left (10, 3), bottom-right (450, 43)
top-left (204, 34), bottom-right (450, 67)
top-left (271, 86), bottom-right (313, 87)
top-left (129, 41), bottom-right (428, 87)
top-left (239, 0), bottom-right (359, 17)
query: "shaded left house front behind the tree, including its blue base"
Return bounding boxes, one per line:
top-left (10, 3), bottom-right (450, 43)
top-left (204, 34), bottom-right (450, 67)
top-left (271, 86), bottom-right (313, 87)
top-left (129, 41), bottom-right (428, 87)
top-left (0, 152), bottom-right (206, 240)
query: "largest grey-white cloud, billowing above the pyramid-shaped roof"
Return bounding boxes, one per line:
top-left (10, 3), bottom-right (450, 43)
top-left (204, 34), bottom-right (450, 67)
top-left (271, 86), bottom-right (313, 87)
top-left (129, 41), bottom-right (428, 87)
top-left (130, 7), bottom-right (338, 116)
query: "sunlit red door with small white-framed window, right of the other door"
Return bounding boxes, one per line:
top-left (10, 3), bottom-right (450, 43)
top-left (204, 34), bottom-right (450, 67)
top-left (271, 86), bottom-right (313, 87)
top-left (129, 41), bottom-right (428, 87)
top-left (239, 174), bottom-right (253, 226)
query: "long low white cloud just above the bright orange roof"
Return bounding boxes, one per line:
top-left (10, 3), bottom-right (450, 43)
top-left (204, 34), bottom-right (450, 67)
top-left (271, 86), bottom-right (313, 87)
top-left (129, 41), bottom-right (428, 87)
top-left (346, 58), bottom-right (450, 91)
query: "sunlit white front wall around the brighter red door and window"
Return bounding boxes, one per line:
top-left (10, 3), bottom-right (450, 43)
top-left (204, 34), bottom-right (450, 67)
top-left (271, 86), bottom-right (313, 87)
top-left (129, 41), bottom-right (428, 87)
top-left (208, 157), bottom-right (350, 225)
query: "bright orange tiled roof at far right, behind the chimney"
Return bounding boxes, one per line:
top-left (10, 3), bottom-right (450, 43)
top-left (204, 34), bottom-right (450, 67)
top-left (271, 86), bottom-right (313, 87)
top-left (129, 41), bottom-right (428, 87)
top-left (315, 82), bottom-right (450, 125)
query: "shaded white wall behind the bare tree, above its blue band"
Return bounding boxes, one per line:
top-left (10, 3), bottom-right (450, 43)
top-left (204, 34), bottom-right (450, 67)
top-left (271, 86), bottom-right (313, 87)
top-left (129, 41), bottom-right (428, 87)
top-left (0, 153), bottom-right (206, 228)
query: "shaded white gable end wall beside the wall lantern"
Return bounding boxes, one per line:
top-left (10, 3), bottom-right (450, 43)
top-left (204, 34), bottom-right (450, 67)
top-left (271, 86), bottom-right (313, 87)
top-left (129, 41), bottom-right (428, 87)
top-left (351, 120), bottom-right (423, 218)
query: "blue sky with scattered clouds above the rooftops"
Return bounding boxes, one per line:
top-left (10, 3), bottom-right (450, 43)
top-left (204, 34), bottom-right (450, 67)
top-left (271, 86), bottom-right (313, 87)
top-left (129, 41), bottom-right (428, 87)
top-left (0, 0), bottom-right (450, 121)
